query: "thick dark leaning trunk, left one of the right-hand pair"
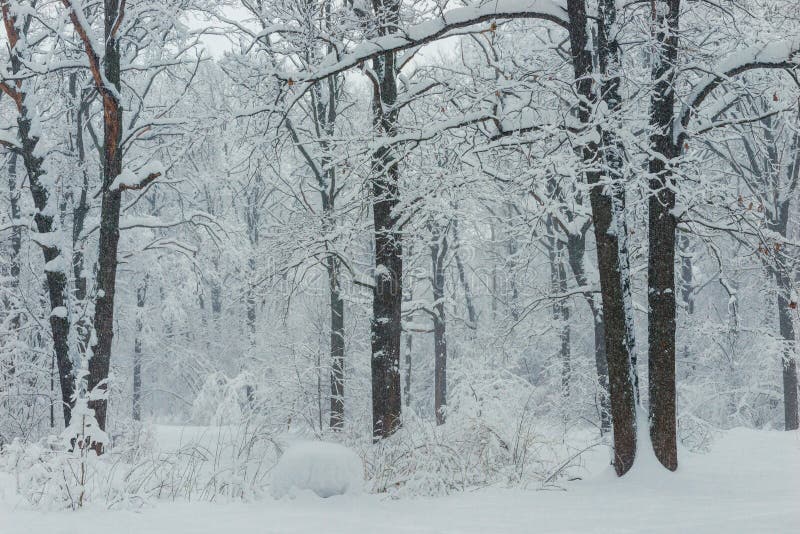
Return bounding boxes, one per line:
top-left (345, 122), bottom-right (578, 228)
top-left (567, 0), bottom-right (636, 476)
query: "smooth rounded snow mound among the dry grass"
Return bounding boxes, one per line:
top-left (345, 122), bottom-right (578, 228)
top-left (271, 441), bottom-right (364, 499)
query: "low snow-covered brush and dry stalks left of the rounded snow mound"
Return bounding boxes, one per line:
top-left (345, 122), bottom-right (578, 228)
top-left (0, 425), bottom-right (277, 509)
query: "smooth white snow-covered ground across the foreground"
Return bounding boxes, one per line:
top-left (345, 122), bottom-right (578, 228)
top-left (0, 429), bottom-right (800, 534)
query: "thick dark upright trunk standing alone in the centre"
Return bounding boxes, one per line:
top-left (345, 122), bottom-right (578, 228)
top-left (371, 0), bottom-right (403, 440)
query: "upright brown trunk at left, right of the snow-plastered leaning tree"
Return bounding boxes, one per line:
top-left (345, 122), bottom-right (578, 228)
top-left (88, 0), bottom-right (122, 436)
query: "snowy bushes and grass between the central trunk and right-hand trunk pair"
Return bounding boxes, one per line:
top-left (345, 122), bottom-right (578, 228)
top-left (364, 360), bottom-right (569, 496)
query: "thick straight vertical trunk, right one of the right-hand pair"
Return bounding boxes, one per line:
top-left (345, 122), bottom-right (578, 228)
top-left (647, 0), bottom-right (680, 471)
